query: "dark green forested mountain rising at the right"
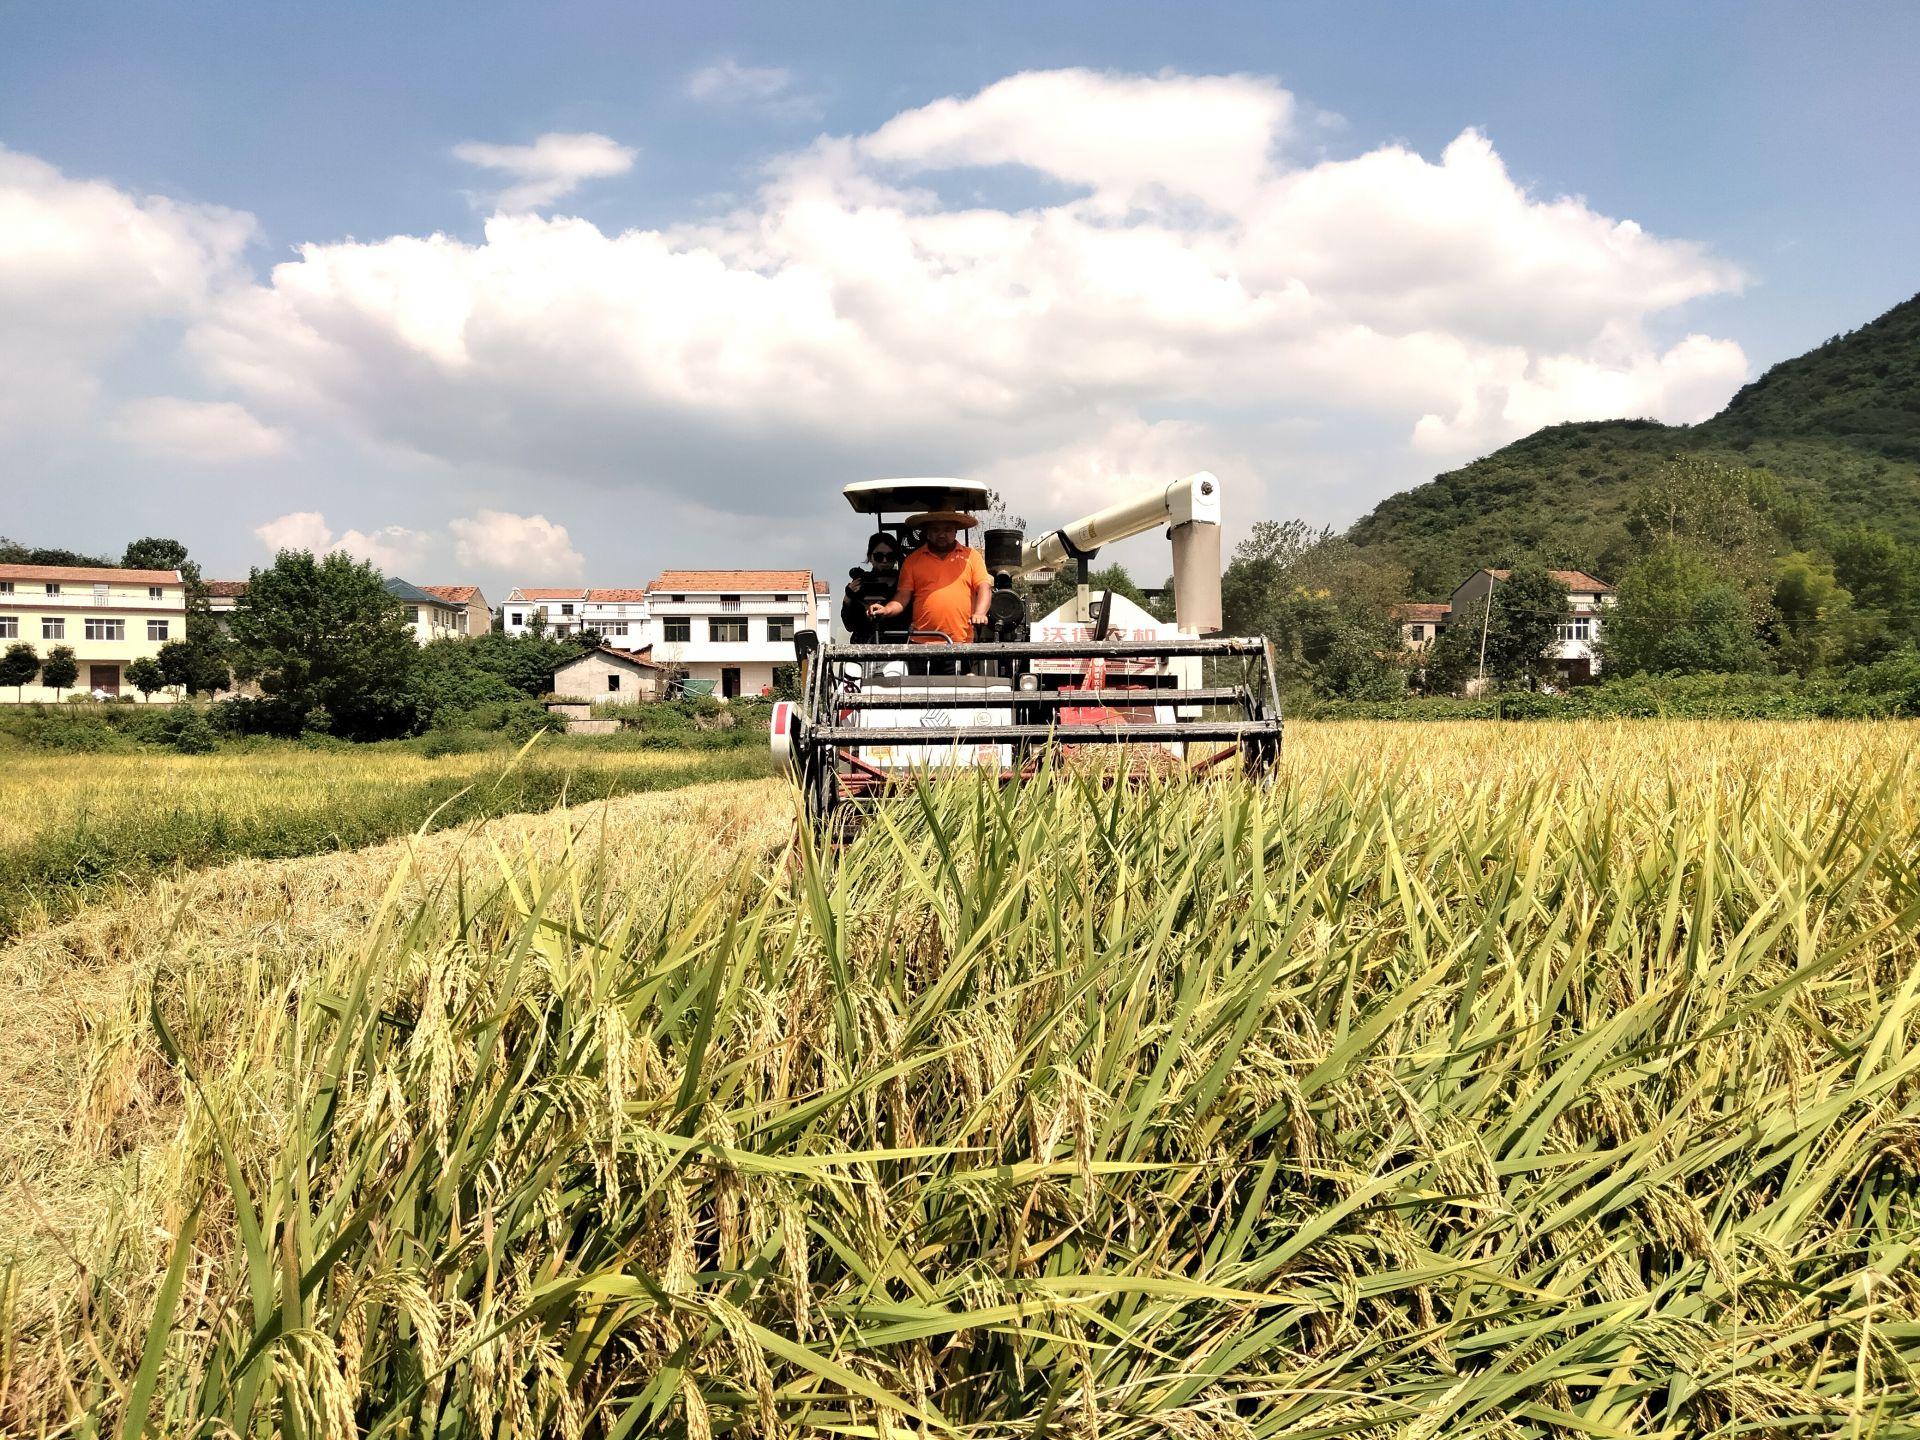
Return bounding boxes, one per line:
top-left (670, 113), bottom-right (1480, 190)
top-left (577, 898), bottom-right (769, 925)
top-left (1348, 296), bottom-right (1920, 597)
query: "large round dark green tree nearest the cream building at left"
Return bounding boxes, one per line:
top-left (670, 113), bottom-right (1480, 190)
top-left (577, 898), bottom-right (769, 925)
top-left (232, 549), bottom-right (420, 739)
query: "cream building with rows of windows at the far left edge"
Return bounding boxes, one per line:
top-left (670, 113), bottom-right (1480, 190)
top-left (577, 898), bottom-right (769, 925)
top-left (0, 564), bottom-right (186, 701)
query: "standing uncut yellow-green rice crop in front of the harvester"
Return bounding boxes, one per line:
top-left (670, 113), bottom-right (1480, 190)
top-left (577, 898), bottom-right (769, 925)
top-left (8, 726), bottom-right (1920, 1436)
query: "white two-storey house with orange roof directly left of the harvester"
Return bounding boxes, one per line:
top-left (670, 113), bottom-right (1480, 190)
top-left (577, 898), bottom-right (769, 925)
top-left (647, 570), bottom-right (831, 699)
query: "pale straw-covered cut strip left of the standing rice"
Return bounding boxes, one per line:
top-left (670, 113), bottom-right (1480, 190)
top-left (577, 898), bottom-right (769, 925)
top-left (0, 780), bottom-right (793, 1286)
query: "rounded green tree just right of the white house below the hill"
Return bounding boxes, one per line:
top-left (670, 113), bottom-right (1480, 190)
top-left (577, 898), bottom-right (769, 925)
top-left (1601, 543), bottom-right (1766, 674)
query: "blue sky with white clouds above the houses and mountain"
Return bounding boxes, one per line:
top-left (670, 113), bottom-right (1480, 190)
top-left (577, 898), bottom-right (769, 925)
top-left (0, 4), bottom-right (1920, 589)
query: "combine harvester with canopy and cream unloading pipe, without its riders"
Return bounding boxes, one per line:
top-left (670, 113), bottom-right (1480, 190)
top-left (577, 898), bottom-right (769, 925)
top-left (772, 472), bottom-right (1281, 829)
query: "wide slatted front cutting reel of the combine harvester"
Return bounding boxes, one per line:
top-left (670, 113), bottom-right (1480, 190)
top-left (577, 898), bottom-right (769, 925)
top-left (772, 637), bottom-right (1281, 835)
